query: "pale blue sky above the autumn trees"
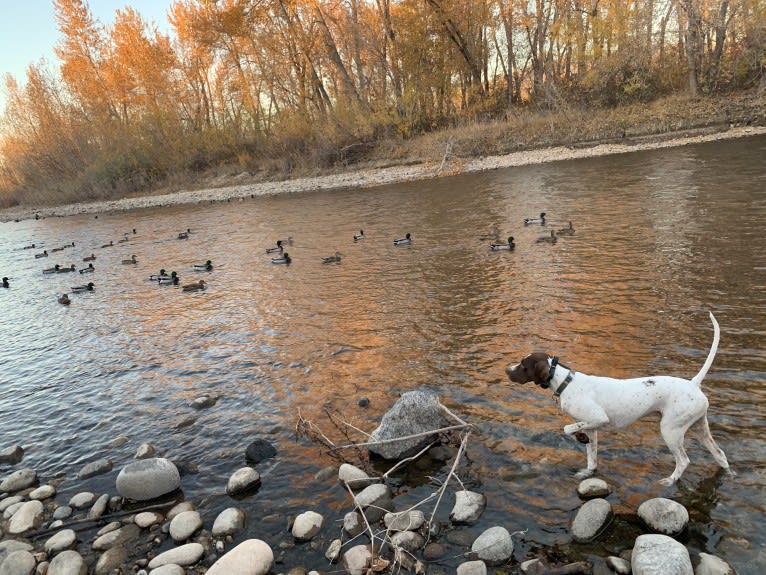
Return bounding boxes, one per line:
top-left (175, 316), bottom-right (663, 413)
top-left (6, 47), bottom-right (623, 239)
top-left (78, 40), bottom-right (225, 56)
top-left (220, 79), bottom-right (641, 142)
top-left (0, 0), bottom-right (172, 111)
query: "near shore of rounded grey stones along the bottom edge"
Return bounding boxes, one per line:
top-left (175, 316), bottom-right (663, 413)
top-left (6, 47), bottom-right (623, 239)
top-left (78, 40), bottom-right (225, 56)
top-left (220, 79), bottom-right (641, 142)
top-left (0, 392), bottom-right (734, 575)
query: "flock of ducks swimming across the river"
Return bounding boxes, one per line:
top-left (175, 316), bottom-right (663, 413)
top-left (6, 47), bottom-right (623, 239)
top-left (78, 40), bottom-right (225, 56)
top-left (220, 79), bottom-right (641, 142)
top-left (2, 212), bottom-right (575, 305)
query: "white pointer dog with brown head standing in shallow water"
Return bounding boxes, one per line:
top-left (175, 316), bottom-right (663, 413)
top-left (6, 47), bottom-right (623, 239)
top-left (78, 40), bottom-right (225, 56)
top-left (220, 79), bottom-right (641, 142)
top-left (505, 313), bottom-right (729, 485)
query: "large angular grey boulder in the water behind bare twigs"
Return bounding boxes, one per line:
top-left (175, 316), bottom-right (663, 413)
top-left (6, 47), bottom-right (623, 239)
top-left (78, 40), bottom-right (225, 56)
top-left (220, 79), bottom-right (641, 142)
top-left (367, 391), bottom-right (445, 459)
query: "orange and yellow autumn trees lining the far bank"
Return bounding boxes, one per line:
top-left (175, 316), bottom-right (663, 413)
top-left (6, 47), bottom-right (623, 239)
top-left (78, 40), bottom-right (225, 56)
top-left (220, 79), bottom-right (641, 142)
top-left (0, 0), bottom-right (766, 205)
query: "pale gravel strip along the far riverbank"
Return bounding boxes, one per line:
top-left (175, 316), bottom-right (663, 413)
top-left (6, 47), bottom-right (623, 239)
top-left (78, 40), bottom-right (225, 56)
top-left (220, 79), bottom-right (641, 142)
top-left (0, 127), bottom-right (766, 222)
